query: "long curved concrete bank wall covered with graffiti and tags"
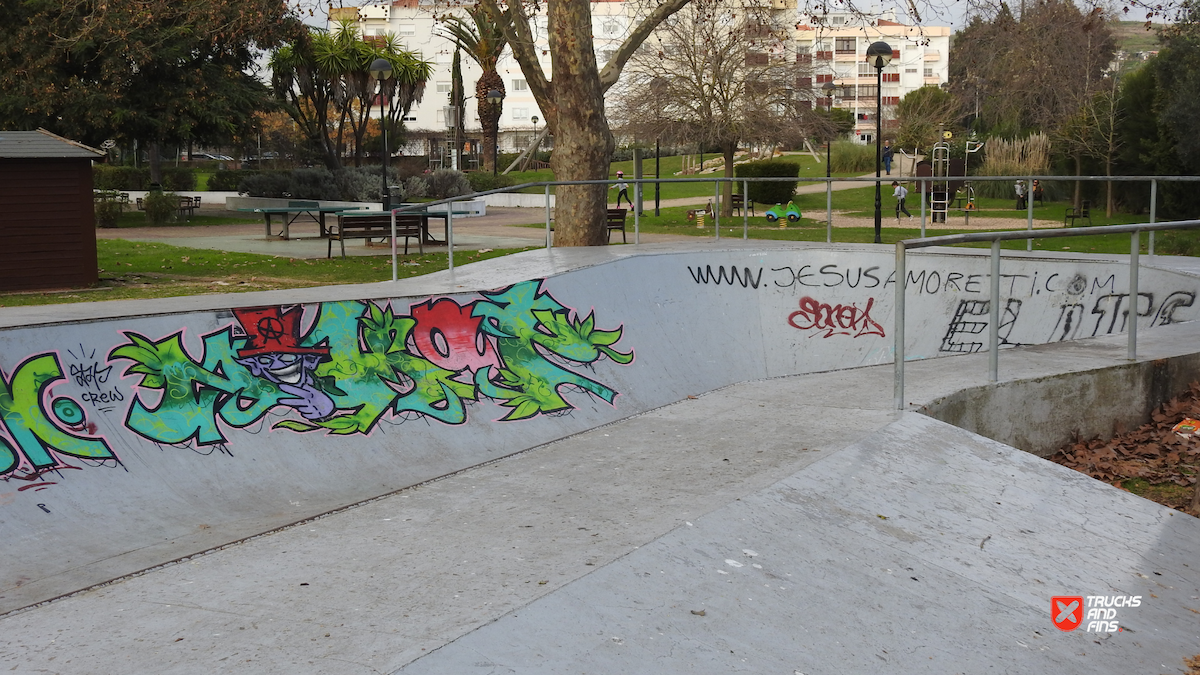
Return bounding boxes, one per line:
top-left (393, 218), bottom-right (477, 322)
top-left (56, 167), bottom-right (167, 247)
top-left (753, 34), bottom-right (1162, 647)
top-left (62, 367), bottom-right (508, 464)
top-left (0, 241), bottom-right (1200, 613)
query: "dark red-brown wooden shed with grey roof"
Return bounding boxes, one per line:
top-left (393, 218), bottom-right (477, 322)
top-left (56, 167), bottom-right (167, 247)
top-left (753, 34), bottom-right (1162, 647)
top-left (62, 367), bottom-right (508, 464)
top-left (0, 130), bottom-right (104, 291)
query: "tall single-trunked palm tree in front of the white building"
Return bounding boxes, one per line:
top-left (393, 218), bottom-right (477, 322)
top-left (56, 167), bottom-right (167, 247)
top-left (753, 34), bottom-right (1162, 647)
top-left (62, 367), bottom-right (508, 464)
top-left (444, 5), bottom-right (509, 171)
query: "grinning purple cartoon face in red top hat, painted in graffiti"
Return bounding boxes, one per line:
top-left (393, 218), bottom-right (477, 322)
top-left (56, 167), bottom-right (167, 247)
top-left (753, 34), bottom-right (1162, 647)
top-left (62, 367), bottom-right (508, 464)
top-left (234, 307), bottom-right (336, 419)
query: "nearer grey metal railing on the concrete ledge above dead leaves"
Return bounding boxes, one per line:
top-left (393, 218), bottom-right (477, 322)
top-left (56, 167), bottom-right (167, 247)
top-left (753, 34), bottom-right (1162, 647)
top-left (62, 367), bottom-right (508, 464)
top-left (892, 220), bottom-right (1200, 410)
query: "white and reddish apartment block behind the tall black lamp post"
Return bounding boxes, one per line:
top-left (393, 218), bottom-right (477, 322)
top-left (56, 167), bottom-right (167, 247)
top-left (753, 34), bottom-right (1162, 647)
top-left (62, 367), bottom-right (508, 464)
top-left (796, 11), bottom-right (950, 143)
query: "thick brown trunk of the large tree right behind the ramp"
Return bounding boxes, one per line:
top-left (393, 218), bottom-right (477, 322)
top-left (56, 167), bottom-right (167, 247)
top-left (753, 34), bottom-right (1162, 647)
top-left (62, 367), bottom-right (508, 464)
top-left (544, 2), bottom-right (616, 246)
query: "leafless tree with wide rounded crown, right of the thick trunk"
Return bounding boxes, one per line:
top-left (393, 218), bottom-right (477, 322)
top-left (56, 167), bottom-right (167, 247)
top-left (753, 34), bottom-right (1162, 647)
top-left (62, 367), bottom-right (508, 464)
top-left (610, 0), bottom-right (826, 215)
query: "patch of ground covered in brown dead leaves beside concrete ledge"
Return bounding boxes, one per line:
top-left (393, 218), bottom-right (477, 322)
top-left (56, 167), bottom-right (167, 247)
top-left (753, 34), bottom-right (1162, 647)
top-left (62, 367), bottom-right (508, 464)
top-left (1050, 382), bottom-right (1200, 515)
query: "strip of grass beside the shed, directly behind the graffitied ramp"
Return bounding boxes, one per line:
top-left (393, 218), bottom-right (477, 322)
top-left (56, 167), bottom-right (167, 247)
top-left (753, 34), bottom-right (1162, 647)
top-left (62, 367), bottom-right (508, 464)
top-left (0, 239), bottom-right (528, 307)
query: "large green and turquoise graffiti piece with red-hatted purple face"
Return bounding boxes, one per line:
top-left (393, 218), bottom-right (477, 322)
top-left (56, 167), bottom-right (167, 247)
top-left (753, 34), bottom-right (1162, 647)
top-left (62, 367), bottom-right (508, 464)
top-left (109, 281), bottom-right (634, 446)
